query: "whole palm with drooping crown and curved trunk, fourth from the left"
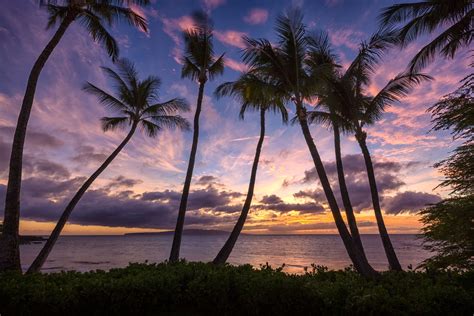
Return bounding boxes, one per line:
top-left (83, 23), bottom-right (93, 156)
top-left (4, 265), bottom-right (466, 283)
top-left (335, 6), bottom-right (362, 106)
top-left (213, 73), bottom-right (288, 264)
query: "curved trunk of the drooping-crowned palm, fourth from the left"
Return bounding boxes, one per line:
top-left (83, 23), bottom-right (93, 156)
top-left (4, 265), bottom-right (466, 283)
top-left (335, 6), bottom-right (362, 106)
top-left (213, 109), bottom-right (265, 264)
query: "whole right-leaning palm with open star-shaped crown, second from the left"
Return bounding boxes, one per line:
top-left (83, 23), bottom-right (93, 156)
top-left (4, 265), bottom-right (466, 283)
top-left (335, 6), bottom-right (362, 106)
top-left (28, 59), bottom-right (189, 273)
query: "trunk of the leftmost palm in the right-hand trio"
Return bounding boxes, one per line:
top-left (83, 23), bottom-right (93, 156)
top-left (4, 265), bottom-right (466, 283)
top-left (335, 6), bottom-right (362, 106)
top-left (296, 104), bottom-right (377, 278)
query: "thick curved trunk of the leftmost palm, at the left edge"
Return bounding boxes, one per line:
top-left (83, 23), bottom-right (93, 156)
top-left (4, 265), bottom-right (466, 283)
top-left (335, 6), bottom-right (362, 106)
top-left (0, 15), bottom-right (75, 271)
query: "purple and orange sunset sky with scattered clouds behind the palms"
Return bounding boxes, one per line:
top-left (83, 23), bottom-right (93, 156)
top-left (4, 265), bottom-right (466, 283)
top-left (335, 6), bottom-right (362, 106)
top-left (0, 0), bottom-right (469, 235)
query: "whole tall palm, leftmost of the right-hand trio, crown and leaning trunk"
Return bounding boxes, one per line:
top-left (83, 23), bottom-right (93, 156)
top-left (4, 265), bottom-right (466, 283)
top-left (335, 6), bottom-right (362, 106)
top-left (243, 10), bottom-right (376, 277)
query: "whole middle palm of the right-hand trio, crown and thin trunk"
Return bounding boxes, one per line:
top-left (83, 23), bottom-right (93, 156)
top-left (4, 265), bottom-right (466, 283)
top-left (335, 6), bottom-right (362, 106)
top-left (308, 33), bottom-right (367, 260)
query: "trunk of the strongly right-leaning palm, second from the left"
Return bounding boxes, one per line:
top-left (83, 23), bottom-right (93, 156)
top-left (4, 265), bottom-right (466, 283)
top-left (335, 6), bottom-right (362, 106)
top-left (27, 123), bottom-right (137, 273)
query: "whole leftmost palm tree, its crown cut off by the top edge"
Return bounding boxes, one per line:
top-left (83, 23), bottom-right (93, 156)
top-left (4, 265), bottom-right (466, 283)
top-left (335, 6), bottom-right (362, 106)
top-left (0, 0), bottom-right (149, 271)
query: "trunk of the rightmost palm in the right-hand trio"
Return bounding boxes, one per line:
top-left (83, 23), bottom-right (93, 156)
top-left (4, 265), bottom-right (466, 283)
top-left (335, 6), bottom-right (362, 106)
top-left (356, 131), bottom-right (402, 271)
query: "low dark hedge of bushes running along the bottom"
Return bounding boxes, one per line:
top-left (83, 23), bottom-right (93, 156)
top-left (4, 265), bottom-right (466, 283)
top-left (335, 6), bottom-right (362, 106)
top-left (0, 262), bottom-right (474, 315)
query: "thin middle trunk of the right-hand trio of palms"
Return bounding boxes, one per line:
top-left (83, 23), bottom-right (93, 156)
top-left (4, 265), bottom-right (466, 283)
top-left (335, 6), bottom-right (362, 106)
top-left (333, 122), bottom-right (367, 260)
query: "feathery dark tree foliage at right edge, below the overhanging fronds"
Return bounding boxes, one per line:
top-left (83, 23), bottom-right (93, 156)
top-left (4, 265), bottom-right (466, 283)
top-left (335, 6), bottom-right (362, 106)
top-left (420, 68), bottom-right (474, 270)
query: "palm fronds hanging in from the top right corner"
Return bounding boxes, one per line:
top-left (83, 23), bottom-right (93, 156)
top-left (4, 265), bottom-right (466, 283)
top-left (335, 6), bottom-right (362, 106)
top-left (379, 0), bottom-right (474, 72)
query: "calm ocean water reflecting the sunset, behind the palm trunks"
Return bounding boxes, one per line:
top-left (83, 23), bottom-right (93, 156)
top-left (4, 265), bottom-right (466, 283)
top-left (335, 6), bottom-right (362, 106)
top-left (21, 235), bottom-right (430, 273)
